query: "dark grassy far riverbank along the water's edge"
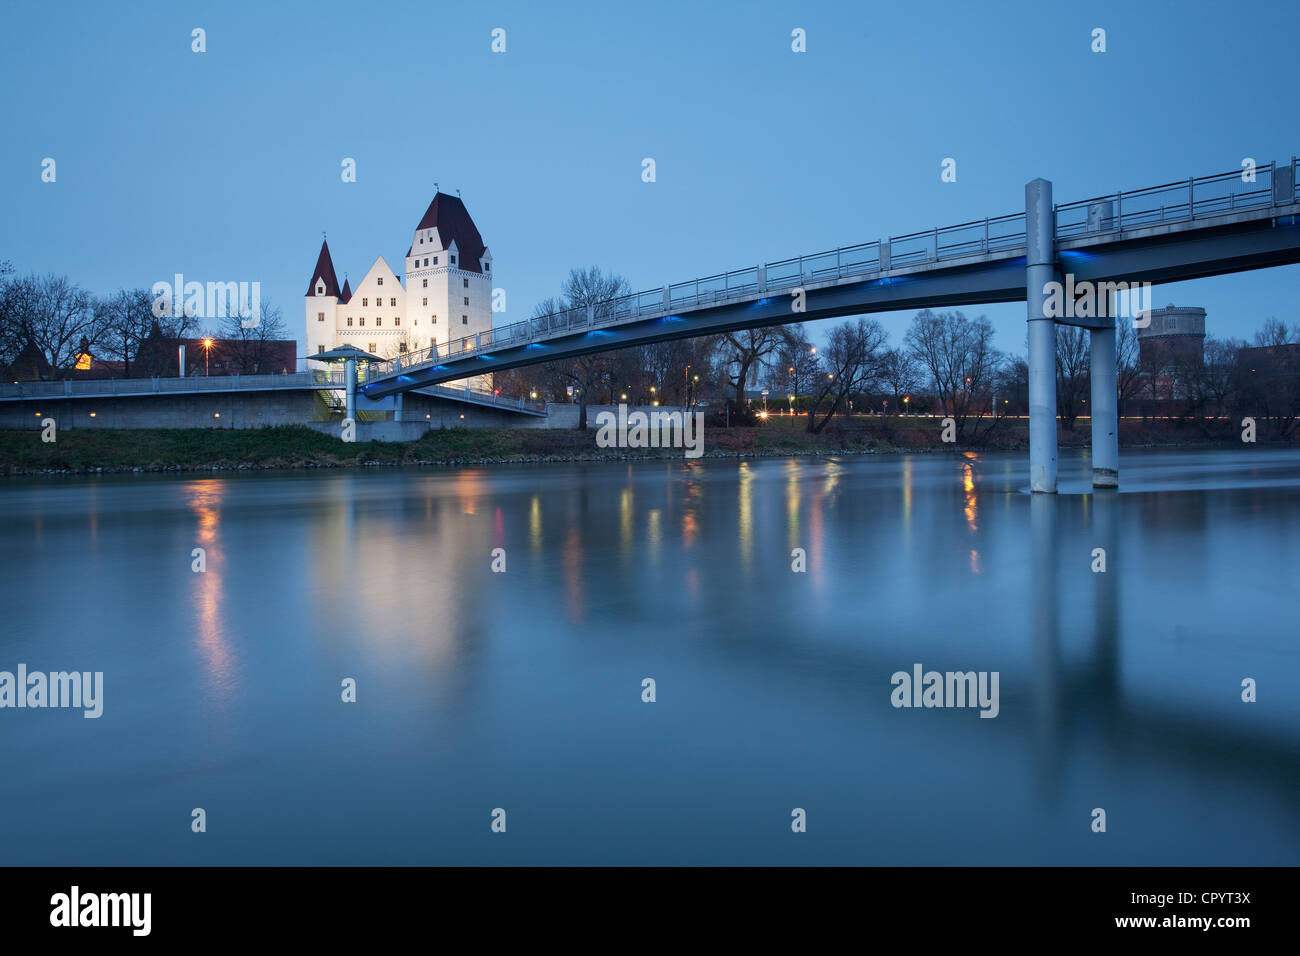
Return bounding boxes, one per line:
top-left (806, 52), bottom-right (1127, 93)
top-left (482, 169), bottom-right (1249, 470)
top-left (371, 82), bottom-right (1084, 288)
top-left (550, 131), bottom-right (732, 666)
top-left (0, 418), bottom-right (1279, 476)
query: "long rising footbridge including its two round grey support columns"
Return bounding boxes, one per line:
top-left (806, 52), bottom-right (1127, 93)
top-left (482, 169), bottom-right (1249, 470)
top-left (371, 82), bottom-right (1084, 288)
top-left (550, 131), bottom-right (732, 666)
top-left (361, 156), bottom-right (1300, 493)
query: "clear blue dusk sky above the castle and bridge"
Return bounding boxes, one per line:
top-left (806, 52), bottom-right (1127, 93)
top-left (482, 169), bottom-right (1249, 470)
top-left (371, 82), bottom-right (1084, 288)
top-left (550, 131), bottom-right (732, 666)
top-left (0, 0), bottom-right (1300, 352)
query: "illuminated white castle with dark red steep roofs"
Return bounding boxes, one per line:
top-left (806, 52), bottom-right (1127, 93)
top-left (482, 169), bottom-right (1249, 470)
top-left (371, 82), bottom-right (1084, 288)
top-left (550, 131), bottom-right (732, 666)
top-left (306, 193), bottom-right (491, 384)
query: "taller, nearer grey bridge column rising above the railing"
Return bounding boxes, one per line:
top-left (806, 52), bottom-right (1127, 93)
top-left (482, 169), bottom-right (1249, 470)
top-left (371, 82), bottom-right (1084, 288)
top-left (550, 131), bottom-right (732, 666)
top-left (1024, 179), bottom-right (1057, 494)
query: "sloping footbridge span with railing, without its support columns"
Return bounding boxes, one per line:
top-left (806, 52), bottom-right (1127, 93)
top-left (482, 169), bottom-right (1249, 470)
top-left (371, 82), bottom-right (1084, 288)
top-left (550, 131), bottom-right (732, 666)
top-left (361, 159), bottom-right (1300, 397)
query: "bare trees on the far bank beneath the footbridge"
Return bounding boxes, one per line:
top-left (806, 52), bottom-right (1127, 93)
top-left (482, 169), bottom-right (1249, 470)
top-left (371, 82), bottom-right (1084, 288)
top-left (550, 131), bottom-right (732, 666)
top-left (497, 268), bottom-right (1300, 441)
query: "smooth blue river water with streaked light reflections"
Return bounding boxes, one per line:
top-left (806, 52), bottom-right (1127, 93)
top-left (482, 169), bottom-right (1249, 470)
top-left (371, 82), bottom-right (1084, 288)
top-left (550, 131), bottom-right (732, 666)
top-left (0, 449), bottom-right (1300, 865)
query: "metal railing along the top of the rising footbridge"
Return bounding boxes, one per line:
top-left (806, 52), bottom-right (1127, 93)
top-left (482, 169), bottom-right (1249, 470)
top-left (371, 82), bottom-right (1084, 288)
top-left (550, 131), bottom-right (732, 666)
top-left (364, 159), bottom-right (1300, 377)
